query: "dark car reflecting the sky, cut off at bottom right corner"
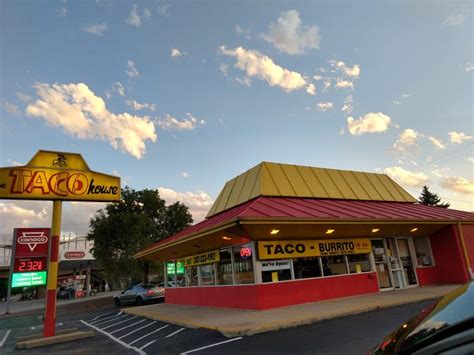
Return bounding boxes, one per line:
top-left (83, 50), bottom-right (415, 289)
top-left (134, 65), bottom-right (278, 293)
top-left (369, 281), bottom-right (474, 355)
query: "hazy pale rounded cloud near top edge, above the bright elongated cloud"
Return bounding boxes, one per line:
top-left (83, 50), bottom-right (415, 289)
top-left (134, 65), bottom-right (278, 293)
top-left (262, 10), bottom-right (321, 55)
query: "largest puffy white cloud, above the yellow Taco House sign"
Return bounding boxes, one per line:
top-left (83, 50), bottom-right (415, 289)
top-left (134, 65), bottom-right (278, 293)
top-left (26, 83), bottom-right (157, 159)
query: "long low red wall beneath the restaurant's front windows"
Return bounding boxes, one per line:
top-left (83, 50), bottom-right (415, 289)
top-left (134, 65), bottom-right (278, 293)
top-left (166, 273), bottom-right (379, 310)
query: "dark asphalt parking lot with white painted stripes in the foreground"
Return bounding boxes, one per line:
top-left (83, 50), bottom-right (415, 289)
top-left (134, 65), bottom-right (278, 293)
top-left (0, 300), bottom-right (433, 355)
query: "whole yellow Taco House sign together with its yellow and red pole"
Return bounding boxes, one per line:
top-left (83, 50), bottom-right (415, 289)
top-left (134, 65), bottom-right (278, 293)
top-left (0, 150), bottom-right (121, 337)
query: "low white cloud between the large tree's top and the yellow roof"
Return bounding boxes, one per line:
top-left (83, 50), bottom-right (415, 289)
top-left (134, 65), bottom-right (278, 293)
top-left (158, 187), bottom-right (214, 222)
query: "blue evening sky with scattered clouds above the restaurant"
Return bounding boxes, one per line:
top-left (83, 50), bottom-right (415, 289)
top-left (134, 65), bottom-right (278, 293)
top-left (0, 0), bottom-right (474, 238)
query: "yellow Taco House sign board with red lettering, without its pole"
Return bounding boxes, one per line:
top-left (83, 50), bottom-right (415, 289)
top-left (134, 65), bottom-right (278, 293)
top-left (0, 150), bottom-right (120, 202)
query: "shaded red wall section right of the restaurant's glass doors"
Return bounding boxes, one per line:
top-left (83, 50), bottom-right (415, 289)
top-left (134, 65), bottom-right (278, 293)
top-left (416, 225), bottom-right (469, 286)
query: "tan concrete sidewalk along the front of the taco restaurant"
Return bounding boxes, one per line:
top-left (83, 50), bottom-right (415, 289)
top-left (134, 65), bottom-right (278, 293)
top-left (123, 285), bottom-right (460, 337)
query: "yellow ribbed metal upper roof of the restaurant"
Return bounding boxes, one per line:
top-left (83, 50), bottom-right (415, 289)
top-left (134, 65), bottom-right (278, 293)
top-left (207, 162), bottom-right (416, 217)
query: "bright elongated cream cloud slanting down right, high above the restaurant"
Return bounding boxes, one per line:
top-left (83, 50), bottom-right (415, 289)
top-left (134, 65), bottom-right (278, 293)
top-left (219, 46), bottom-right (311, 92)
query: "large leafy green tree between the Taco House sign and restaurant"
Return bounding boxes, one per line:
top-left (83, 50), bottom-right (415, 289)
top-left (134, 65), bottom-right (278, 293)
top-left (87, 187), bottom-right (193, 283)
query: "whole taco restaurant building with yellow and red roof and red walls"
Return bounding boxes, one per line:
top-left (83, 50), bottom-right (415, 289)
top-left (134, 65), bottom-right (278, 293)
top-left (136, 162), bottom-right (474, 310)
